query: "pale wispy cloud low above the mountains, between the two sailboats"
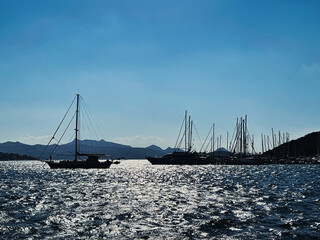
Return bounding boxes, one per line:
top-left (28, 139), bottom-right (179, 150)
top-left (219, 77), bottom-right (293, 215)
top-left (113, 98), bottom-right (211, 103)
top-left (112, 136), bottom-right (167, 148)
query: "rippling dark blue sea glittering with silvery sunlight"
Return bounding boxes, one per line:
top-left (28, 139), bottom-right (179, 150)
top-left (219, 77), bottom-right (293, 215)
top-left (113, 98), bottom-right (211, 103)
top-left (0, 160), bottom-right (320, 239)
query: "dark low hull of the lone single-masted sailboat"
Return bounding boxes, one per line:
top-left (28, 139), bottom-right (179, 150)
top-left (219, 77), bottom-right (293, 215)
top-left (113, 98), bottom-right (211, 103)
top-left (45, 161), bottom-right (112, 169)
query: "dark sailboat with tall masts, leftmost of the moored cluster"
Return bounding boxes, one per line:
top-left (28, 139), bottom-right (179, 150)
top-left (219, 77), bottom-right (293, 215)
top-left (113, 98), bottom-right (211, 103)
top-left (146, 111), bottom-right (213, 165)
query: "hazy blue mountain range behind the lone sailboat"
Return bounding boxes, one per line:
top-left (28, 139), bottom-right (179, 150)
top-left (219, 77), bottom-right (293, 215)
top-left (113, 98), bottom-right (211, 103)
top-left (0, 140), bottom-right (173, 159)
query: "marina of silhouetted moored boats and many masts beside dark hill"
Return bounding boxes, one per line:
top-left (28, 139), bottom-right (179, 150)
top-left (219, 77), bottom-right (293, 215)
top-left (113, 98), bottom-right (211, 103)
top-left (146, 111), bottom-right (320, 165)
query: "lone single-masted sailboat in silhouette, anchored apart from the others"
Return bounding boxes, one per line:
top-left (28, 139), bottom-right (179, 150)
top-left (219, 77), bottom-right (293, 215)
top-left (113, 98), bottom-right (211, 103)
top-left (41, 94), bottom-right (113, 169)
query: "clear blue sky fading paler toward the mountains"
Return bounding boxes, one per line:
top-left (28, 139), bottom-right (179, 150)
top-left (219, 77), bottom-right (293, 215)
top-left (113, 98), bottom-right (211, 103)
top-left (0, 0), bottom-right (320, 151)
